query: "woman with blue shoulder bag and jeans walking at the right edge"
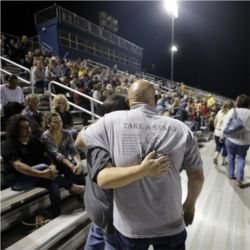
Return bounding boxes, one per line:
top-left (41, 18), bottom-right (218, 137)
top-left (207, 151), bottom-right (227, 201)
top-left (222, 94), bottom-right (250, 188)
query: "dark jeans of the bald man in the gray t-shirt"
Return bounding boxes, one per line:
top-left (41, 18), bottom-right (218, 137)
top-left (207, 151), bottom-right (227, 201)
top-left (116, 230), bottom-right (187, 250)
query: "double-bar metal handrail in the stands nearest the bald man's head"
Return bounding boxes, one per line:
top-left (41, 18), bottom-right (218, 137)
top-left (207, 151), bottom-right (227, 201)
top-left (48, 81), bottom-right (103, 120)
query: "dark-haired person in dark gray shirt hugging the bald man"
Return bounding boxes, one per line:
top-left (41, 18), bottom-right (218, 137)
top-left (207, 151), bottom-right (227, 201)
top-left (80, 95), bottom-right (170, 250)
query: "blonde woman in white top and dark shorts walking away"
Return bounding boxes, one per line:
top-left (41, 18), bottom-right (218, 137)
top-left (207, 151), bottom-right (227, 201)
top-left (214, 100), bottom-right (233, 166)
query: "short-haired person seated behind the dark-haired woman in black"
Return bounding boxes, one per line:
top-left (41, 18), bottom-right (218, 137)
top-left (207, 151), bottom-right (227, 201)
top-left (21, 94), bottom-right (42, 138)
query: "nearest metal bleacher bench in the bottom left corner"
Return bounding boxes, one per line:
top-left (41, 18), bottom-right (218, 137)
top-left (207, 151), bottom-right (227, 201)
top-left (6, 210), bottom-right (90, 250)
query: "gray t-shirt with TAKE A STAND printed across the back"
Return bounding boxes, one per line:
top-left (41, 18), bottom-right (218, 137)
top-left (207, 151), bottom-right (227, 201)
top-left (81, 104), bottom-right (202, 238)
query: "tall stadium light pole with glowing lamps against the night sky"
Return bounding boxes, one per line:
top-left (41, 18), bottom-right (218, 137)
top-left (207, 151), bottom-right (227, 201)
top-left (164, 0), bottom-right (178, 81)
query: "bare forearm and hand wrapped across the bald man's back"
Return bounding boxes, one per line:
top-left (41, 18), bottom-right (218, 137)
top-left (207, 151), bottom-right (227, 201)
top-left (97, 152), bottom-right (170, 189)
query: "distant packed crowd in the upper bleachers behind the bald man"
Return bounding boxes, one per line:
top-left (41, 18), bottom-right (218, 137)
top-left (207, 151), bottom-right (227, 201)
top-left (1, 33), bottom-right (223, 135)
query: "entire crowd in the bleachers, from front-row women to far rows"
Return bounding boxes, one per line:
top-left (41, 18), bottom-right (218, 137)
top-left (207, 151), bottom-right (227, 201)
top-left (1, 32), bottom-right (249, 246)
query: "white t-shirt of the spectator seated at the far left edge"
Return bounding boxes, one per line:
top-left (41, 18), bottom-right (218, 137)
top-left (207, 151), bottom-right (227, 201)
top-left (0, 84), bottom-right (24, 106)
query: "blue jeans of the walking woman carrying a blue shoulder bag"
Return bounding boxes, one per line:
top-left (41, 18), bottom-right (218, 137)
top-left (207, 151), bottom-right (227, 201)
top-left (225, 139), bottom-right (249, 181)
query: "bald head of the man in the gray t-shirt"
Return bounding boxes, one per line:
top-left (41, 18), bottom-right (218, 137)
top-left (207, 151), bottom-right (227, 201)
top-left (128, 80), bottom-right (155, 106)
